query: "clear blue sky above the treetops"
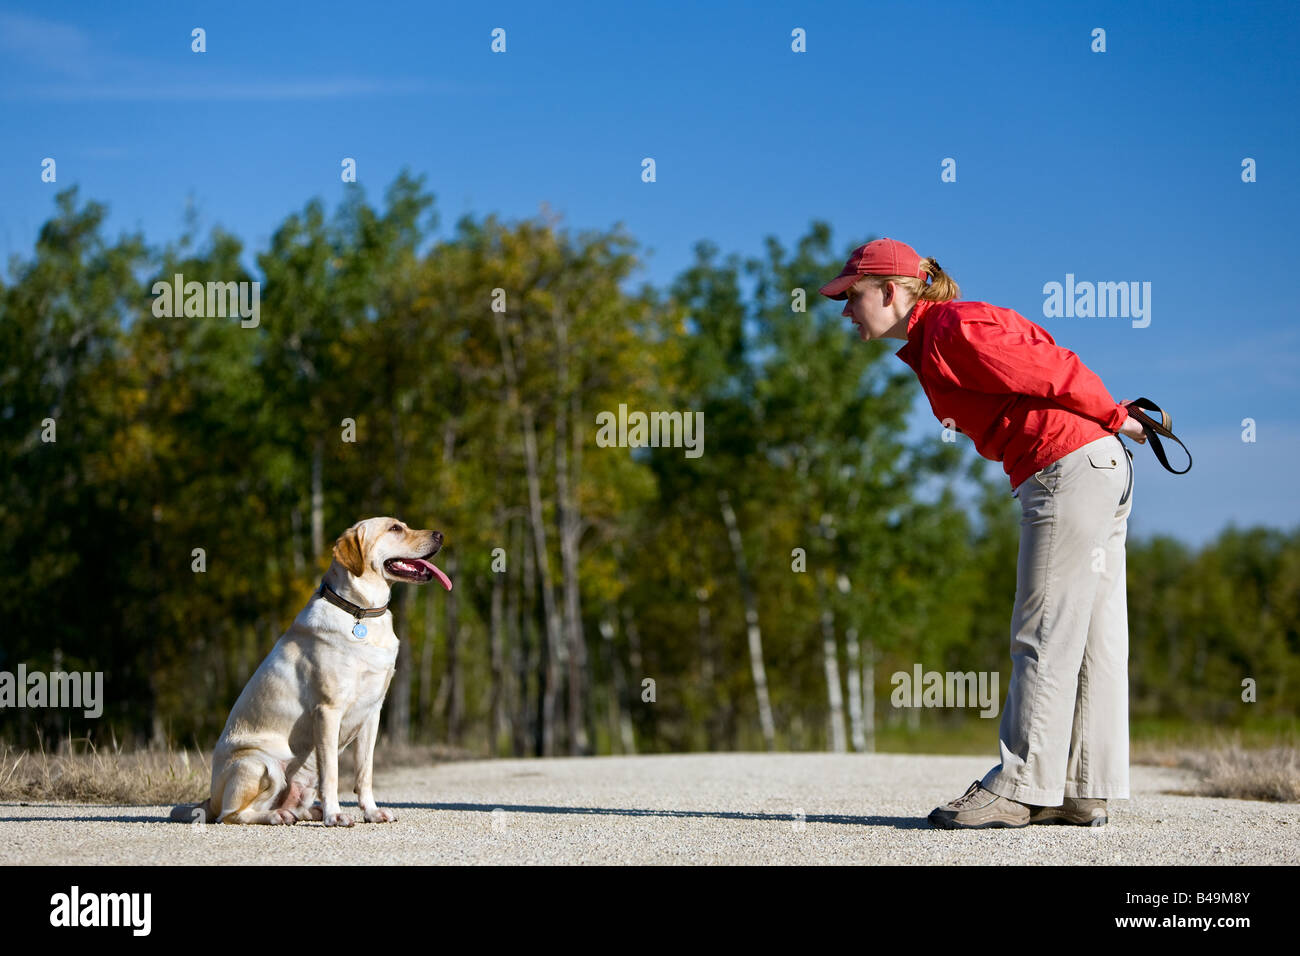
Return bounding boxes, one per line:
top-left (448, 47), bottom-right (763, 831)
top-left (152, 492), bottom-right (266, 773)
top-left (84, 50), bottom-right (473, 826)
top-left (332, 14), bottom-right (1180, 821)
top-left (0, 3), bottom-right (1300, 542)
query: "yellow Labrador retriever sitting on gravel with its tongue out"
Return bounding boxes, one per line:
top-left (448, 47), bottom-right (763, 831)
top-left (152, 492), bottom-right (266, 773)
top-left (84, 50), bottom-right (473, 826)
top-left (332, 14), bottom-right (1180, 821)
top-left (172, 518), bottom-right (451, 826)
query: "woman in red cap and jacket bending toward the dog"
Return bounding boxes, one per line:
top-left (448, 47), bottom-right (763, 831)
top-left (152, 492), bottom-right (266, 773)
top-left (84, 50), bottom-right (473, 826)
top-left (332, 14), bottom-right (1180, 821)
top-left (820, 239), bottom-right (1145, 829)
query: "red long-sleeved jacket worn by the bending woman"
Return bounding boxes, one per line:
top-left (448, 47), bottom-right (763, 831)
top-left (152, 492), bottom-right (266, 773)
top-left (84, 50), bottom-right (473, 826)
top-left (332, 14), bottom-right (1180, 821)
top-left (898, 300), bottom-right (1128, 488)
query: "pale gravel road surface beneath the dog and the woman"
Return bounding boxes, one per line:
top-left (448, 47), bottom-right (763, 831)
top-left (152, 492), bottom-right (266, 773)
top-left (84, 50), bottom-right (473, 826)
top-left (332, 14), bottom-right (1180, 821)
top-left (0, 753), bottom-right (1300, 865)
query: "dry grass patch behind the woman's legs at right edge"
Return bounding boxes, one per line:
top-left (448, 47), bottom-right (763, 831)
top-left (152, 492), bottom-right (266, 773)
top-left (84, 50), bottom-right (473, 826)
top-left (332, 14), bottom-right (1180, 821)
top-left (1131, 732), bottom-right (1300, 803)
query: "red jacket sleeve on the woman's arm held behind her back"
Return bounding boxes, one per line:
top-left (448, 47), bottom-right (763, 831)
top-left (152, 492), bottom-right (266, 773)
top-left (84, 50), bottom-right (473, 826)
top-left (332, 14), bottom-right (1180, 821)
top-left (932, 319), bottom-right (1128, 432)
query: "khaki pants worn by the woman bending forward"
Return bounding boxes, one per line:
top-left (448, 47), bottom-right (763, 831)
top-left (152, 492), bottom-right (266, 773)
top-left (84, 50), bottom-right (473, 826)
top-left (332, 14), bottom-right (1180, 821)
top-left (980, 436), bottom-right (1132, 806)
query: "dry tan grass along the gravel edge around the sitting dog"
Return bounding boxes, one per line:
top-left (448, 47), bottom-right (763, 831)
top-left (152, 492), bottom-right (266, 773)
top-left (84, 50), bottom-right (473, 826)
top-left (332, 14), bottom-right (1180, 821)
top-left (0, 736), bottom-right (483, 805)
